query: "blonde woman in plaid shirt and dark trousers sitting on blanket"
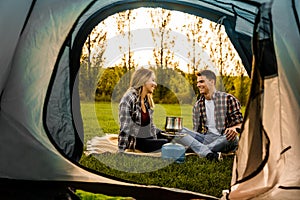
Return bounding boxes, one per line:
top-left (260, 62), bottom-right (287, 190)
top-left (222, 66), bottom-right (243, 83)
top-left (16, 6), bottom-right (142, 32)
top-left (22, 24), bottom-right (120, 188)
top-left (118, 68), bottom-right (168, 152)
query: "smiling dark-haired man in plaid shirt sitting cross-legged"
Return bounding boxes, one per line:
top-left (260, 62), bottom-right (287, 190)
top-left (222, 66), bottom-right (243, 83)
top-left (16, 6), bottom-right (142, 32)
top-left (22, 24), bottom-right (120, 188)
top-left (178, 70), bottom-right (243, 160)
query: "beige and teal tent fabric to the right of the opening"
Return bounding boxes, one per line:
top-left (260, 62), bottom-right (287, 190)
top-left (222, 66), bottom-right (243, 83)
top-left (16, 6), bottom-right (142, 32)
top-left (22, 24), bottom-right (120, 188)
top-left (229, 1), bottom-right (300, 199)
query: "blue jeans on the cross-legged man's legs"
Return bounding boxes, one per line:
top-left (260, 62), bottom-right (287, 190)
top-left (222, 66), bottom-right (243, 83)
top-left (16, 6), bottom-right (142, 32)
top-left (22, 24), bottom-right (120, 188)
top-left (176, 128), bottom-right (238, 157)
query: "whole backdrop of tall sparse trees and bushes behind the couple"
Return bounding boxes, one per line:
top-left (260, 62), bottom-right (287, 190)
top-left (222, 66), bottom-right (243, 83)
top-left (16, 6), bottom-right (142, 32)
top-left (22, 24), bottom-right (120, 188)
top-left (79, 8), bottom-right (249, 105)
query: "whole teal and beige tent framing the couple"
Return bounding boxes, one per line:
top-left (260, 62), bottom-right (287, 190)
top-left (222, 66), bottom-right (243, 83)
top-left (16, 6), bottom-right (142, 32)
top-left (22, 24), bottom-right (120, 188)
top-left (0, 0), bottom-right (300, 199)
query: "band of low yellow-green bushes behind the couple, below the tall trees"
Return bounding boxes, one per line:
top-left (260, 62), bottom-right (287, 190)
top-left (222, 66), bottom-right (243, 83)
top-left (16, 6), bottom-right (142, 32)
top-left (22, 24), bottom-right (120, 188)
top-left (80, 66), bottom-right (251, 106)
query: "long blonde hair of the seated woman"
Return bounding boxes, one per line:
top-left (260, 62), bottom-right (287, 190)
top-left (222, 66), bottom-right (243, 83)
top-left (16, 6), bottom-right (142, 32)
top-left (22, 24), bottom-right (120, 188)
top-left (129, 68), bottom-right (154, 108)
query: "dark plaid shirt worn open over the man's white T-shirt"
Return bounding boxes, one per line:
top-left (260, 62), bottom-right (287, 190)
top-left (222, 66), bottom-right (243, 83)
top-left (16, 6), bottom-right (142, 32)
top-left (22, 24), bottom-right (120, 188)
top-left (193, 91), bottom-right (243, 134)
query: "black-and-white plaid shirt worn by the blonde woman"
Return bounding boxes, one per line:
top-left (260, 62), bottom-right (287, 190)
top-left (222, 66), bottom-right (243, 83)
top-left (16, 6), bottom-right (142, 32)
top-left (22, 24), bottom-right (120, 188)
top-left (118, 88), bottom-right (157, 152)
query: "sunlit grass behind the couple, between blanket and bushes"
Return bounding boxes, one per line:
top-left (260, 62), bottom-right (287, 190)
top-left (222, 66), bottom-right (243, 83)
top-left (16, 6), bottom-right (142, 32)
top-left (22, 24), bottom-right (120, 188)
top-left (81, 102), bottom-right (192, 142)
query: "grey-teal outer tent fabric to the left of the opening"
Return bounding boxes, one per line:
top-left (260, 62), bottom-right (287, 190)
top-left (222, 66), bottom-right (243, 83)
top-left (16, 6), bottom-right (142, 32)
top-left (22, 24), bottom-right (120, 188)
top-left (0, 1), bottom-right (106, 180)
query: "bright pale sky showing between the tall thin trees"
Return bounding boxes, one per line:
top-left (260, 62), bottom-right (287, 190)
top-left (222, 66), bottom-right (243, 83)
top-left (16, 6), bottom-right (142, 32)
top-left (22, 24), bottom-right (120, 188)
top-left (86, 8), bottom-right (242, 73)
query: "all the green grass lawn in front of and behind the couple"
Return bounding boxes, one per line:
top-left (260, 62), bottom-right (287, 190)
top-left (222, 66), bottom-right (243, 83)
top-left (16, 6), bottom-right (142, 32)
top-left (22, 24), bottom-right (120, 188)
top-left (78, 103), bottom-right (239, 199)
